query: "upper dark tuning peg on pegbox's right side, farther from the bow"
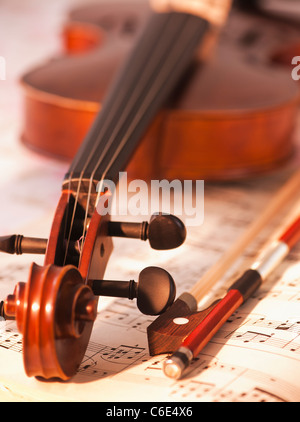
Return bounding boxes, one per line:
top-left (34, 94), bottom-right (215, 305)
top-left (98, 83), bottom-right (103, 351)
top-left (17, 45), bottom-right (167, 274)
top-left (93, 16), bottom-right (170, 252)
top-left (108, 213), bottom-right (186, 250)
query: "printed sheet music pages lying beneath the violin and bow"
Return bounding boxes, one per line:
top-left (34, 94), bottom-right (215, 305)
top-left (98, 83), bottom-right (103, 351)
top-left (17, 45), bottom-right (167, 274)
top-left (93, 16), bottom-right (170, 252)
top-left (0, 2), bottom-right (300, 402)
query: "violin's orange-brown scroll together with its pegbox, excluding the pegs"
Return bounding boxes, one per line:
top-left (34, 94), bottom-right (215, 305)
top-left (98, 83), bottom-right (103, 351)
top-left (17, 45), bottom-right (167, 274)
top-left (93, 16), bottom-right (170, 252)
top-left (4, 190), bottom-right (112, 380)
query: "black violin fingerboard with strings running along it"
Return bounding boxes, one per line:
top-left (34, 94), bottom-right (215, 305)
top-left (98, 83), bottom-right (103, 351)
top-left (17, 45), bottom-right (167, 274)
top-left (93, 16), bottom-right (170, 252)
top-left (64, 13), bottom-right (209, 185)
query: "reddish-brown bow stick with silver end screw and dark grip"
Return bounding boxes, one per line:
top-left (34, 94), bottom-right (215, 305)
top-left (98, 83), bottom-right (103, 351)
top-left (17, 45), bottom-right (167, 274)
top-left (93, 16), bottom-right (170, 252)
top-left (163, 207), bottom-right (300, 379)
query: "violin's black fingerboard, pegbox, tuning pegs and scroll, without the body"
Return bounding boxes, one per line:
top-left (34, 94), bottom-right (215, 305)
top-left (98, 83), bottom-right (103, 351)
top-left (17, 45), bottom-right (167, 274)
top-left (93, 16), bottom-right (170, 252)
top-left (0, 2), bottom-right (231, 380)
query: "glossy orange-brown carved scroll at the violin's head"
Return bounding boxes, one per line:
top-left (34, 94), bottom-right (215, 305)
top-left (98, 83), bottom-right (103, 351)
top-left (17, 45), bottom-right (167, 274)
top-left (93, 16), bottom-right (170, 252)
top-left (4, 264), bottom-right (97, 380)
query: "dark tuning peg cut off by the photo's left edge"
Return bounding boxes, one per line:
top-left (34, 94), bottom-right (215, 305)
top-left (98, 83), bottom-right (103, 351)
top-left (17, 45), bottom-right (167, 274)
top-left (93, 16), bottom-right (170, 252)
top-left (0, 234), bottom-right (48, 255)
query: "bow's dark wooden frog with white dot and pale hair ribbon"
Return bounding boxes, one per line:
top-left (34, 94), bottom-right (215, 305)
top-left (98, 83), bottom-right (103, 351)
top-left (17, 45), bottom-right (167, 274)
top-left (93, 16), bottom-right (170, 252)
top-left (147, 171), bottom-right (300, 362)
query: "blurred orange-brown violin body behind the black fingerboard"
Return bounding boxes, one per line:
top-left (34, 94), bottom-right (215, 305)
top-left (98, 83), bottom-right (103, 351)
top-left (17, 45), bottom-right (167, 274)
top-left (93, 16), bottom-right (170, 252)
top-left (21, 0), bottom-right (299, 180)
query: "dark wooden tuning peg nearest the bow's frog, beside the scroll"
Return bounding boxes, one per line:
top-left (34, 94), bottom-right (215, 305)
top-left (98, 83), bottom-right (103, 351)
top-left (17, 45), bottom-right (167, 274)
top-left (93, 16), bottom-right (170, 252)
top-left (92, 267), bottom-right (176, 315)
